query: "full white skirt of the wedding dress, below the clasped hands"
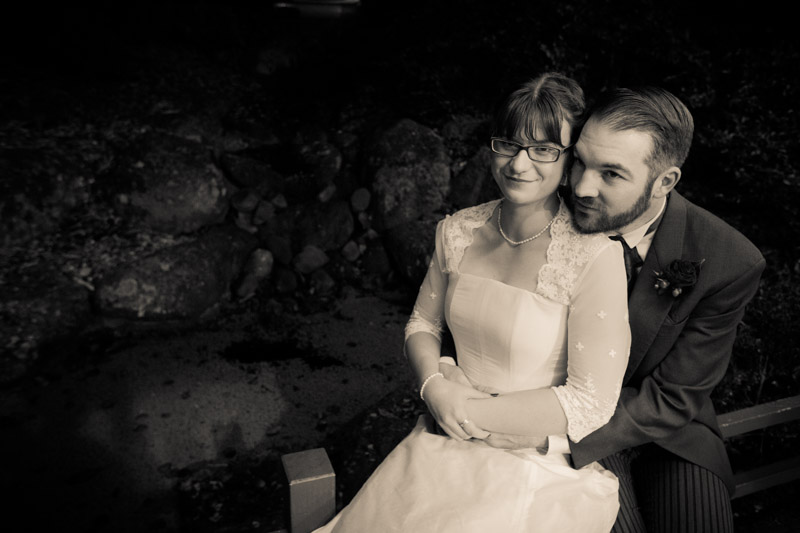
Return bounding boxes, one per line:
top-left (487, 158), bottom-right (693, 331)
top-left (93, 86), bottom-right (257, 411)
top-left (317, 416), bottom-right (619, 533)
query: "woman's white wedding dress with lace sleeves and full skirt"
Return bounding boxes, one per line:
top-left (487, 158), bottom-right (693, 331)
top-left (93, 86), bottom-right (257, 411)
top-left (317, 201), bottom-right (630, 533)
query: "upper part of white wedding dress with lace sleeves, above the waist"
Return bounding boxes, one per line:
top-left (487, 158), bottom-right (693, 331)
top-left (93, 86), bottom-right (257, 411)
top-left (406, 201), bottom-right (630, 441)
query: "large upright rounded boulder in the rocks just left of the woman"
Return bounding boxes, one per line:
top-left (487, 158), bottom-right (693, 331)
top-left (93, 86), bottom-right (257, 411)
top-left (368, 119), bottom-right (450, 229)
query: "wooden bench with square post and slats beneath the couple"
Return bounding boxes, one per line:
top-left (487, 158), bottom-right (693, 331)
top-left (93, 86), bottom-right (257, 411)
top-left (274, 396), bottom-right (800, 533)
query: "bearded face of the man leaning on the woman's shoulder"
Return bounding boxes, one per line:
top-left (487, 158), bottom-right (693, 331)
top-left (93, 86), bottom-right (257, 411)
top-left (570, 119), bottom-right (653, 233)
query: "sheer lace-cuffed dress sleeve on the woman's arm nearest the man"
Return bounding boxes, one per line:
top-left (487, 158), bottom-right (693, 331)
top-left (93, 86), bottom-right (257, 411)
top-left (553, 243), bottom-right (631, 442)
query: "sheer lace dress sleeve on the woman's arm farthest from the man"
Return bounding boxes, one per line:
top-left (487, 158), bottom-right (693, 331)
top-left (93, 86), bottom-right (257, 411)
top-left (405, 219), bottom-right (447, 341)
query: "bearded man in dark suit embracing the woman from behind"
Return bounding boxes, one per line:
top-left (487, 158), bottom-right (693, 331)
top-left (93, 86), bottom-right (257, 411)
top-left (440, 88), bottom-right (765, 532)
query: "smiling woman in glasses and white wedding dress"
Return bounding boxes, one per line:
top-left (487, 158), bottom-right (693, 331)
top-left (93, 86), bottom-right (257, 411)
top-left (317, 73), bottom-right (630, 533)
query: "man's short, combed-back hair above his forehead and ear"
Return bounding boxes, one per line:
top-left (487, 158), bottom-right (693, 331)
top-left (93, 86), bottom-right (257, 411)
top-left (589, 87), bottom-right (694, 178)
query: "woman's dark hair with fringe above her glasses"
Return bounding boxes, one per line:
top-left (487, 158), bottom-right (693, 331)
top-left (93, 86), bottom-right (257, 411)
top-left (492, 72), bottom-right (586, 145)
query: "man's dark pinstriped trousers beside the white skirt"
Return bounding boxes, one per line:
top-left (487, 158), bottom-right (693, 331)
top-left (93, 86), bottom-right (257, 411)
top-left (600, 445), bottom-right (733, 533)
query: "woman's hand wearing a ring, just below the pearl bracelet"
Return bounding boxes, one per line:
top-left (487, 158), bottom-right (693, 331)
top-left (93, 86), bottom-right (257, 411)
top-left (425, 377), bottom-right (491, 440)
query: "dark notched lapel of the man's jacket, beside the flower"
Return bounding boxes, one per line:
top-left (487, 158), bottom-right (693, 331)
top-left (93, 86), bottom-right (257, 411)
top-left (624, 191), bottom-right (686, 383)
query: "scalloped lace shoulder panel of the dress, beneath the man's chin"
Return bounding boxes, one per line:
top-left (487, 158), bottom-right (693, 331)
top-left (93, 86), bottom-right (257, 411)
top-left (536, 201), bottom-right (614, 305)
